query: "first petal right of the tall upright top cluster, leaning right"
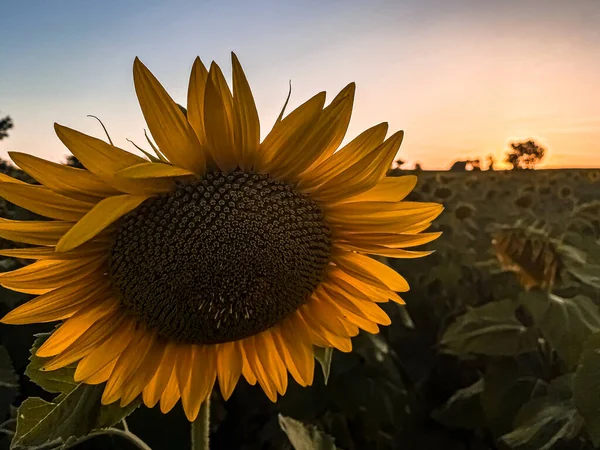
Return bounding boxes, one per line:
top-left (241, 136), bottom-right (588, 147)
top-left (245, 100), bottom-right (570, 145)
top-left (256, 92), bottom-right (325, 173)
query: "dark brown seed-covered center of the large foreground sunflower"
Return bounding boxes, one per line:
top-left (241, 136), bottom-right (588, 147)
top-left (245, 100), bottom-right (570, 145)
top-left (109, 170), bottom-right (332, 344)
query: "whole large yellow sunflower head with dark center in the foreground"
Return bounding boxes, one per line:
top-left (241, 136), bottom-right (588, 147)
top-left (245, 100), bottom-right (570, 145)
top-left (0, 55), bottom-right (441, 420)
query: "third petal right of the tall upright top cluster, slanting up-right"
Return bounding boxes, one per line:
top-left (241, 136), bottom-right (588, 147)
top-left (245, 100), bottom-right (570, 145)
top-left (298, 123), bottom-right (388, 192)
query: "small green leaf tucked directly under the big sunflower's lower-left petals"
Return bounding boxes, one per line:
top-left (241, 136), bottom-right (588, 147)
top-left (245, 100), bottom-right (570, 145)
top-left (25, 333), bottom-right (77, 394)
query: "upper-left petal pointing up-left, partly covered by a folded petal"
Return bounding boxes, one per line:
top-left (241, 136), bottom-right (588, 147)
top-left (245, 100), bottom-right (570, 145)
top-left (54, 124), bottom-right (175, 195)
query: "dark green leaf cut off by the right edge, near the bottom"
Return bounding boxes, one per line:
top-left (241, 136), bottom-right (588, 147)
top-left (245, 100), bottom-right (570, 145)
top-left (574, 333), bottom-right (600, 446)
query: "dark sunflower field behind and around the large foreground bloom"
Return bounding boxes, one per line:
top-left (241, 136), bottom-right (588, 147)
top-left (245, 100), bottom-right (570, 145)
top-left (0, 169), bottom-right (600, 450)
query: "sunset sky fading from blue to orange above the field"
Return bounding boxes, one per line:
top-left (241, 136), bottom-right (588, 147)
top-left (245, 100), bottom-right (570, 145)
top-left (0, 0), bottom-right (600, 169)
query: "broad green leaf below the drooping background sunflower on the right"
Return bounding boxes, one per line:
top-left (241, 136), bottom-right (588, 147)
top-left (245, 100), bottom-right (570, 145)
top-left (440, 300), bottom-right (536, 356)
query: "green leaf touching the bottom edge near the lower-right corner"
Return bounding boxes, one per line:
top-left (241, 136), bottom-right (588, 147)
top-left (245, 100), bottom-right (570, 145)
top-left (500, 374), bottom-right (583, 450)
